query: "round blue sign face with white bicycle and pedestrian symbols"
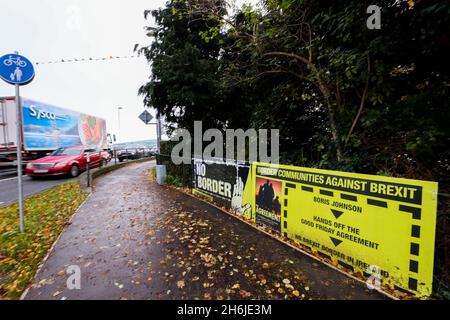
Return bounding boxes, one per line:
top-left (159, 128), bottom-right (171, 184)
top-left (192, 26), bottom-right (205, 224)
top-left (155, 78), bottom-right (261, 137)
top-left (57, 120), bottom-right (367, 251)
top-left (0, 53), bottom-right (34, 85)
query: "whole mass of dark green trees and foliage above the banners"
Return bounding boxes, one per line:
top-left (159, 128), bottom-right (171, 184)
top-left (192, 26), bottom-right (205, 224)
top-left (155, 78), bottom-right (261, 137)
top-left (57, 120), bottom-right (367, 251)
top-left (140, 0), bottom-right (450, 180)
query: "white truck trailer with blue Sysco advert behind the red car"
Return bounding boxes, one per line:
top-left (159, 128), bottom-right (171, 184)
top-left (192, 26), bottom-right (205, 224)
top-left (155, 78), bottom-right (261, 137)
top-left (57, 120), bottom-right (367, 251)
top-left (0, 97), bottom-right (108, 169)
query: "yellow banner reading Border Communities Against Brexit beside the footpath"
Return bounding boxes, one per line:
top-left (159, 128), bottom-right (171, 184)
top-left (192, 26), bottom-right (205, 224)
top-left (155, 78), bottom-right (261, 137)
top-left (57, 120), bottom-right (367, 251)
top-left (251, 163), bottom-right (438, 297)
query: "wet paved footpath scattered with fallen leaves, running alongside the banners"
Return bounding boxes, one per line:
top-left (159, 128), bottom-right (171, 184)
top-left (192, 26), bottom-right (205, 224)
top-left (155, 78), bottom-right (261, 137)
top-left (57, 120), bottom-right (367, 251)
top-left (25, 162), bottom-right (384, 300)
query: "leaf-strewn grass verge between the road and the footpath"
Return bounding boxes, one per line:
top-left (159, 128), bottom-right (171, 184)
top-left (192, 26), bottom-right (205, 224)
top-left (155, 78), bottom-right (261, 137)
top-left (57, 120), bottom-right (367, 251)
top-left (0, 182), bottom-right (88, 300)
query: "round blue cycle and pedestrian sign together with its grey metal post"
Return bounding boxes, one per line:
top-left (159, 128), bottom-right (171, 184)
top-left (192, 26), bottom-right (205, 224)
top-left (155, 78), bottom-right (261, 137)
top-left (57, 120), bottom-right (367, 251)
top-left (0, 51), bottom-right (34, 232)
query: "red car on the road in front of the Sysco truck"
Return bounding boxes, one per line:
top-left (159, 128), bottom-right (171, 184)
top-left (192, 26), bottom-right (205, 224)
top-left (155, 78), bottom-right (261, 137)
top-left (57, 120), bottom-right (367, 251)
top-left (25, 146), bottom-right (108, 178)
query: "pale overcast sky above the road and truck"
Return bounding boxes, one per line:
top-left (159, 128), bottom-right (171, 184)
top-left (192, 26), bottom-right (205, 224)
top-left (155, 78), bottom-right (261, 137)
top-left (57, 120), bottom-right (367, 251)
top-left (0, 0), bottom-right (253, 141)
